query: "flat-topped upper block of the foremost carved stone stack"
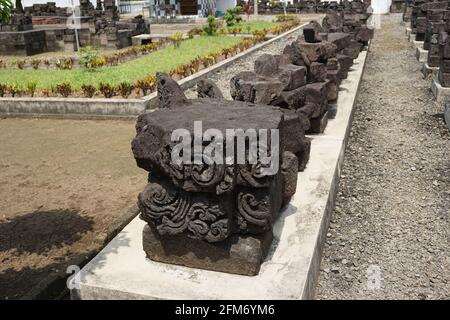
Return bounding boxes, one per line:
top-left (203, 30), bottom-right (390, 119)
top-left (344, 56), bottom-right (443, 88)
top-left (132, 99), bottom-right (290, 194)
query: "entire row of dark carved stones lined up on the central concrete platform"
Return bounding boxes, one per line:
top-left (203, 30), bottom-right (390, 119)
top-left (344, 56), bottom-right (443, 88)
top-left (132, 14), bottom-right (371, 275)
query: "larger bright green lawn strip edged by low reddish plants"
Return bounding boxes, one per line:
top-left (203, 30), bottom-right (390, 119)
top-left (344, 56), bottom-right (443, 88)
top-left (0, 36), bottom-right (242, 90)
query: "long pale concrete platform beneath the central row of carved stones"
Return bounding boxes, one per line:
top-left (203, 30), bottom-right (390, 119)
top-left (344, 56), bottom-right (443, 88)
top-left (71, 51), bottom-right (367, 299)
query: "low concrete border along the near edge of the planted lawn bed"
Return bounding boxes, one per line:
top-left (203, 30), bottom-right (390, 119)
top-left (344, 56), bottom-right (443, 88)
top-left (0, 22), bottom-right (309, 119)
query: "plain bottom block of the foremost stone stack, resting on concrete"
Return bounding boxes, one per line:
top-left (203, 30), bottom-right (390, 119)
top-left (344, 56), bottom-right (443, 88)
top-left (143, 225), bottom-right (273, 276)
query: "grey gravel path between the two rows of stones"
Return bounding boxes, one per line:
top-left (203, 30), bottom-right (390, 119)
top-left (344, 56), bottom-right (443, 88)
top-left (316, 24), bottom-right (450, 299)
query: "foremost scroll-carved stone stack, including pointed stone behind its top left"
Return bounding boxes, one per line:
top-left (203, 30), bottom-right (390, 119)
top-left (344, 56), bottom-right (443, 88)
top-left (132, 74), bottom-right (305, 275)
